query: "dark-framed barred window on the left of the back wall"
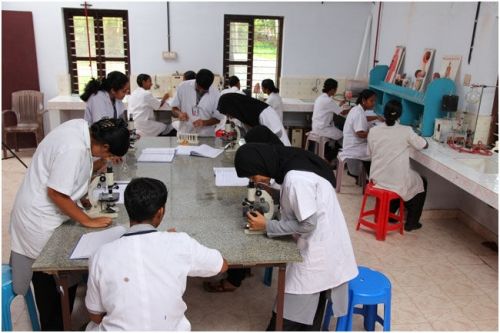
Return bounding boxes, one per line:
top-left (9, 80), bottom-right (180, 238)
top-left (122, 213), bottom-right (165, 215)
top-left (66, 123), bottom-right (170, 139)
top-left (63, 8), bottom-right (130, 94)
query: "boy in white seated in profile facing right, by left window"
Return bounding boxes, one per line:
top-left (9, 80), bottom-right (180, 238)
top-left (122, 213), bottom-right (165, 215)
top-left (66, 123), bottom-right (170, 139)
top-left (128, 74), bottom-right (175, 136)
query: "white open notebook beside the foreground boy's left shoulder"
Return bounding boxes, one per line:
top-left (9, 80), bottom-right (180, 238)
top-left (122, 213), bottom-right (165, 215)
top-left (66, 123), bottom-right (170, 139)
top-left (69, 225), bottom-right (127, 259)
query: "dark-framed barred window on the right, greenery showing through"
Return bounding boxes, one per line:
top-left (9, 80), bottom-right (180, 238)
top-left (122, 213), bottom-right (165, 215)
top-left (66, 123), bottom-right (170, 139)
top-left (223, 15), bottom-right (283, 89)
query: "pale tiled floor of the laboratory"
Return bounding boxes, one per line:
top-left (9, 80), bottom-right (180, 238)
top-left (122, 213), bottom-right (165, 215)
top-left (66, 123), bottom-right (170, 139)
top-left (2, 152), bottom-right (498, 331)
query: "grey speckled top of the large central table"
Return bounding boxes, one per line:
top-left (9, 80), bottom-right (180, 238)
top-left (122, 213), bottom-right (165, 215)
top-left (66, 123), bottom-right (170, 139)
top-left (33, 137), bottom-right (302, 272)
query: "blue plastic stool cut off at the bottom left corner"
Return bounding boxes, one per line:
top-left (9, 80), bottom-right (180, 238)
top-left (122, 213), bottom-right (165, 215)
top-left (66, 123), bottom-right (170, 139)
top-left (2, 265), bottom-right (40, 331)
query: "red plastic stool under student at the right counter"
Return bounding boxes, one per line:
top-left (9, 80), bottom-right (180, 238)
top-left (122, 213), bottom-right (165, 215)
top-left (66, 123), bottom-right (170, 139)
top-left (356, 182), bottom-right (404, 240)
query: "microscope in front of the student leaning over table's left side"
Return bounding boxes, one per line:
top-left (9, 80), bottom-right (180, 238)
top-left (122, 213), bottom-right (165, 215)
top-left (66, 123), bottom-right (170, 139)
top-left (86, 162), bottom-right (120, 218)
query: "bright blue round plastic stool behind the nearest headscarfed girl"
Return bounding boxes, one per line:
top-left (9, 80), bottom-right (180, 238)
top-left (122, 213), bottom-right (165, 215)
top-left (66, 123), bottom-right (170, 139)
top-left (322, 266), bottom-right (391, 331)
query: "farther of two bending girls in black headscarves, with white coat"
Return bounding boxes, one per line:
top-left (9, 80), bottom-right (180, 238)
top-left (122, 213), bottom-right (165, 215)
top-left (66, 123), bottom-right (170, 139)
top-left (217, 94), bottom-right (291, 146)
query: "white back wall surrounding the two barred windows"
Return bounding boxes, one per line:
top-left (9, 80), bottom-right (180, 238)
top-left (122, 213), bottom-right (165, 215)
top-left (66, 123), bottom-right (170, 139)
top-left (2, 1), bottom-right (372, 105)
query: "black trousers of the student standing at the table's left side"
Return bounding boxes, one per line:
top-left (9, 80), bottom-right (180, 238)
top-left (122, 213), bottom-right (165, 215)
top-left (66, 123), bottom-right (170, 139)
top-left (31, 272), bottom-right (77, 331)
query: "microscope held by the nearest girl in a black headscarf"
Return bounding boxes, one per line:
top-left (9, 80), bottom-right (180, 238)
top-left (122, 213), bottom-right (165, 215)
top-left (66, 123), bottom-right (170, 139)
top-left (242, 181), bottom-right (274, 234)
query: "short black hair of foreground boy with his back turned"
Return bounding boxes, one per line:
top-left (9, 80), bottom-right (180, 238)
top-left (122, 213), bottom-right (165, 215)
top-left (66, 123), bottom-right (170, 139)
top-left (124, 177), bottom-right (168, 222)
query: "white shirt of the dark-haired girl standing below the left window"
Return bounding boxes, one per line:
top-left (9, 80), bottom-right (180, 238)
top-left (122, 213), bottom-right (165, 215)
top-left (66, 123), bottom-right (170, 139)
top-left (84, 90), bottom-right (126, 124)
